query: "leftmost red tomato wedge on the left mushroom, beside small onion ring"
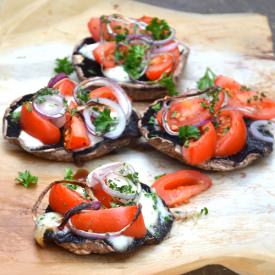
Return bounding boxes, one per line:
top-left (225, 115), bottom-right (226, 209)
top-left (20, 102), bottom-right (61, 145)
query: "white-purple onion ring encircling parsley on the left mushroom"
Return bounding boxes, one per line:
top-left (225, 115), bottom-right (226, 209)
top-left (83, 97), bottom-right (126, 139)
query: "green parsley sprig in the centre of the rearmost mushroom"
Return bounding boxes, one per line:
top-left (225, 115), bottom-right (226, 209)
top-left (123, 45), bottom-right (146, 79)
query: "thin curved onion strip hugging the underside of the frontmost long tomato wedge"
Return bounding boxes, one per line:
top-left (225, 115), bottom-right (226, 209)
top-left (68, 204), bottom-right (141, 240)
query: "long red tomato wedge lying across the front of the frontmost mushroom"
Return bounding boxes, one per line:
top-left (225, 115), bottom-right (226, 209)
top-left (71, 205), bottom-right (147, 238)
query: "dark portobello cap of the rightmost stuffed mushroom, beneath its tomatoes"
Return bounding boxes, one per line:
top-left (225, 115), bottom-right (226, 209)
top-left (138, 99), bottom-right (273, 171)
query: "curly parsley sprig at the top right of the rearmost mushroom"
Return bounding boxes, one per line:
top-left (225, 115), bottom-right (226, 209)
top-left (146, 17), bottom-right (171, 40)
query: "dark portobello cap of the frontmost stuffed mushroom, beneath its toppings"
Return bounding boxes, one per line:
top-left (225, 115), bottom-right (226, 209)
top-left (39, 183), bottom-right (174, 255)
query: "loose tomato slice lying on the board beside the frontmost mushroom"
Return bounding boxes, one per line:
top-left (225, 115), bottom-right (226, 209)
top-left (153, 170), bottom-right (212, 207)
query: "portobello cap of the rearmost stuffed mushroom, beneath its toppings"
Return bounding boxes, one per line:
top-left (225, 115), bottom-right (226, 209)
top-left (72, 37), bottom-right (189, 101)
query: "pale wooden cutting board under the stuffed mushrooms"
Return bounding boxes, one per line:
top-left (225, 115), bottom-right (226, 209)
top-left (0, 0), bottom-right (275, 275)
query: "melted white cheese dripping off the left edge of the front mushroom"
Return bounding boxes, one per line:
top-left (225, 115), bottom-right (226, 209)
top-left (34, 212), bottom-right (63, 246)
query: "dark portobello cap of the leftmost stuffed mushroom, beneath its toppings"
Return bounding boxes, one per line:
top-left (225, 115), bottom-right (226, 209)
top-left (2, 94), bottom-right (140, 163)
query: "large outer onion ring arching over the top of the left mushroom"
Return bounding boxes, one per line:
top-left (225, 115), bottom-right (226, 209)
top-left (74, 77), bottom-right (132, 121)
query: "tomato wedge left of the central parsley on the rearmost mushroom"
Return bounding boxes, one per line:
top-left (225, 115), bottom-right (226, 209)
top-left (93, 42), bottom-right (116, 68)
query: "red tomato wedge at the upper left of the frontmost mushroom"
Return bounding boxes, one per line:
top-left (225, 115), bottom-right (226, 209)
top-left (49, 183), bottom-right (88, 215)
